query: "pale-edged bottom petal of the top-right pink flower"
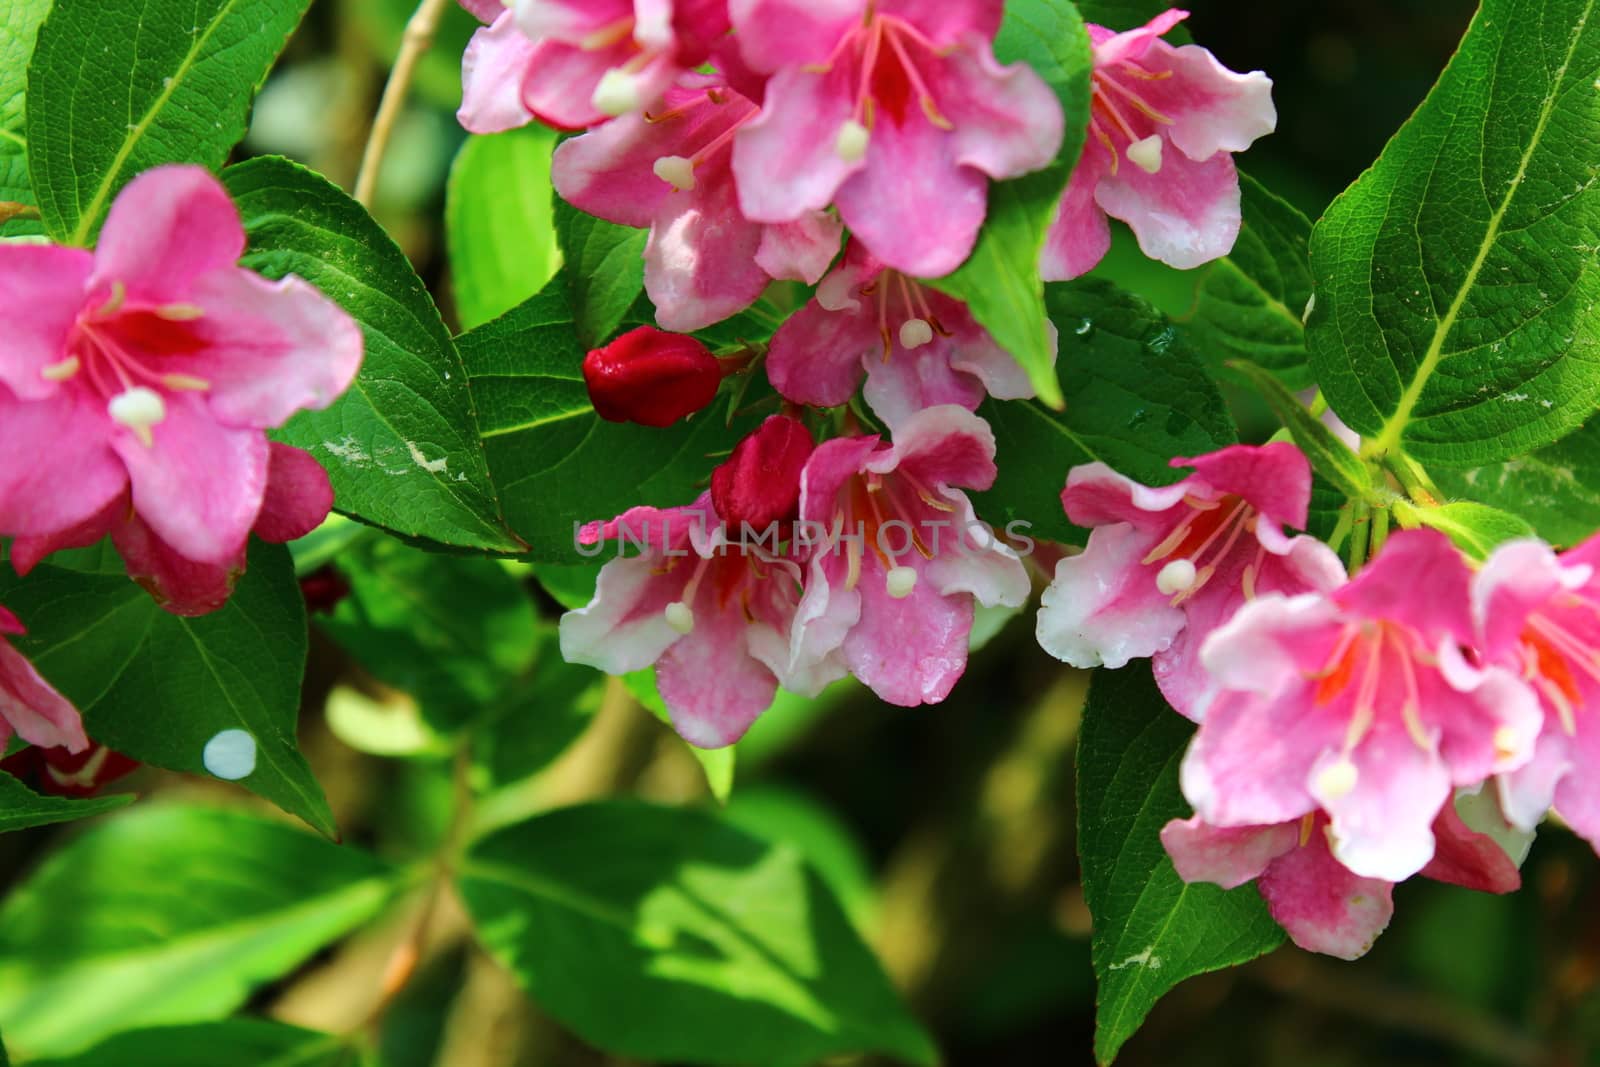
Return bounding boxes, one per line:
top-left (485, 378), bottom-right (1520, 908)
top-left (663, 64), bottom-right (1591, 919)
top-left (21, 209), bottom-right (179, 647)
top-left (1094, 143), bottom-right (1240, 270)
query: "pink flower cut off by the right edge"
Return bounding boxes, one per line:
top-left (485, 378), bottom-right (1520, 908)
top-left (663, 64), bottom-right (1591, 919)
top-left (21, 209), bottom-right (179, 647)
top-left (1472, 537), bottom-right (1600, 848)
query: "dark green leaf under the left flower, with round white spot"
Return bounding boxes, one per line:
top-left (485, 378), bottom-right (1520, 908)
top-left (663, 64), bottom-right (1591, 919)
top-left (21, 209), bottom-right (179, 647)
top-left (0, 542), bottom-right (334, 837)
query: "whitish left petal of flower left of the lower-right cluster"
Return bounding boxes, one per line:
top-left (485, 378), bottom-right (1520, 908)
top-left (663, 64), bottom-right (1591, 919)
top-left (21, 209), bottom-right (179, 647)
top-left (1037, 523), bottom-right (1187, 668)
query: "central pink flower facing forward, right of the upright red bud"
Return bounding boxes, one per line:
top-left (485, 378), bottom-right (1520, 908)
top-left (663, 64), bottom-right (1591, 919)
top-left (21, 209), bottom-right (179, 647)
top-left (795, 405), bottom-right (1029, 707)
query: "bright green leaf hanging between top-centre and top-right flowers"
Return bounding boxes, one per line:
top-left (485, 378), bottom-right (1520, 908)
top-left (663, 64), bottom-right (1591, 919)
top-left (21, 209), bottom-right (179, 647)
top-left (931, 0), bottom-right (1094, 408)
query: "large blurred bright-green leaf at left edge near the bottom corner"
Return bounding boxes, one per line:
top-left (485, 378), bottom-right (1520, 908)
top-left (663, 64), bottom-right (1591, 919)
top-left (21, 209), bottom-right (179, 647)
top-left (0, 805), bottom-right (397, 1067)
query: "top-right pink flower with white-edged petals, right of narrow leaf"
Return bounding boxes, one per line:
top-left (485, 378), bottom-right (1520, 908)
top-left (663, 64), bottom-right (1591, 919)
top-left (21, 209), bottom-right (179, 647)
top-left (1040, 10), bottom-right (1278, 280)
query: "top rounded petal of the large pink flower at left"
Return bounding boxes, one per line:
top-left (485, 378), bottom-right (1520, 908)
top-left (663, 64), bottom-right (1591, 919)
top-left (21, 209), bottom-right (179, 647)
top-left (90, 165), bottom-right (245, 304)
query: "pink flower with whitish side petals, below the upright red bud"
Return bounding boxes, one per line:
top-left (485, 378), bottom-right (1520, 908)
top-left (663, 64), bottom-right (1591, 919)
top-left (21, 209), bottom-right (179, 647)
top-left (560, 494), bottom-right (843, 749)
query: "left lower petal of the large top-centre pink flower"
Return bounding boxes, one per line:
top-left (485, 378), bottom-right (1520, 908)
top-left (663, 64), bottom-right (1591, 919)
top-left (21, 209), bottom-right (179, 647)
top-left (733, 65), bottom-right (870, 222)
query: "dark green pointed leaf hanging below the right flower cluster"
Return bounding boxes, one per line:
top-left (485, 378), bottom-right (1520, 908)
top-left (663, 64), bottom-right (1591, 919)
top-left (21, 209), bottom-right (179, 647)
top-left (1078, 664), bottom-right (1283, 1064)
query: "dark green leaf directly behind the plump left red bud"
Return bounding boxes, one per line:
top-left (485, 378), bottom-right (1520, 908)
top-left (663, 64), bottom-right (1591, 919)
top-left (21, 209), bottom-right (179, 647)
top-left (459, 283), bottom-right (760, 563)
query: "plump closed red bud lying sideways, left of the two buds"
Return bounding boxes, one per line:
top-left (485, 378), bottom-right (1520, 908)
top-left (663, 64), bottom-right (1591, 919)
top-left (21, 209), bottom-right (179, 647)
top-left (584, 326), bottom-right (722, 427)
